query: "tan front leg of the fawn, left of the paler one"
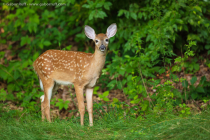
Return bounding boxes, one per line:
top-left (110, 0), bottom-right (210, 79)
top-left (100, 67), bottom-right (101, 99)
top-left (75, 85), bottom-right (85, 125)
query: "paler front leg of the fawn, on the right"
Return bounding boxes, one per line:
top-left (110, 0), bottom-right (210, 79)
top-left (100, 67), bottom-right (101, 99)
top-left (86, 88), bottom-right (93, 126)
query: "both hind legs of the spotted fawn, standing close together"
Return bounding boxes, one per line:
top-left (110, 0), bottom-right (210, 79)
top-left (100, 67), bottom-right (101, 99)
top-left (40, 78), bottom-right (54, 122)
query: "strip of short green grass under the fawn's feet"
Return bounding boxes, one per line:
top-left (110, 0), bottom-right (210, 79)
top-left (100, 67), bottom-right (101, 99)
top-left (0, 106), bottom-right (210, 140)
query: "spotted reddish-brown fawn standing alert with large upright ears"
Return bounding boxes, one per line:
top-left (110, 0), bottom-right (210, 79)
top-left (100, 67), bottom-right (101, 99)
top-left (33, 23), bottom-right (117, 126)
